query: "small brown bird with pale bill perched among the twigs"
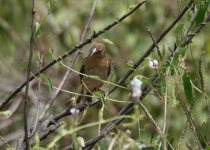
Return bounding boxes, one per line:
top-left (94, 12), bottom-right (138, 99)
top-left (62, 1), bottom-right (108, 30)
top-left (77, 42), bottom-right (111, 103)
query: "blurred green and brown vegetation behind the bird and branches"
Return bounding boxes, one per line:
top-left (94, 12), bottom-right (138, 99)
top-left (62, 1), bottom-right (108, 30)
top-left (0, 0), bottom-right (210, 149)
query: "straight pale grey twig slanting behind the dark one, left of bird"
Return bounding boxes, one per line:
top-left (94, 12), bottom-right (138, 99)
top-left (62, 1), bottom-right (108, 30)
top-left (39, 0), bottom-right (98, 120)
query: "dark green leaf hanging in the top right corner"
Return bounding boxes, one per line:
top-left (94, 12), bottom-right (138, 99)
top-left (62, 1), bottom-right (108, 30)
top-left (196, 0), bottom-right (210, 25)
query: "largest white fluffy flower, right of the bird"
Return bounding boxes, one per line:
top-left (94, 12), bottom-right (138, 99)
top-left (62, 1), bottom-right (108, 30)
top-left (130, 78), bottom-right (142, 102)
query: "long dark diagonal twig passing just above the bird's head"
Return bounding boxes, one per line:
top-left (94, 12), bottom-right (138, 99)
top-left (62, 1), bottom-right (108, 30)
top-left (0, 0), bottom-right (147, 110)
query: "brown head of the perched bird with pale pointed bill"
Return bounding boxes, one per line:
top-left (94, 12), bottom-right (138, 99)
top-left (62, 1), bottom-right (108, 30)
top-left (89, 42), bottom-right (106, 57)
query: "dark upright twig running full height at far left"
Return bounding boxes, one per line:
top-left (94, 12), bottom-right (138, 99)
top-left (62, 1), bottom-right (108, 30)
top-left (24, 0), bottom-right (36, 150)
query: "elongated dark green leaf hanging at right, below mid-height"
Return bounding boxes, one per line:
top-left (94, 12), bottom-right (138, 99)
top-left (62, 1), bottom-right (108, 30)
top-left (182, 72), bottom-right (193, 104)
